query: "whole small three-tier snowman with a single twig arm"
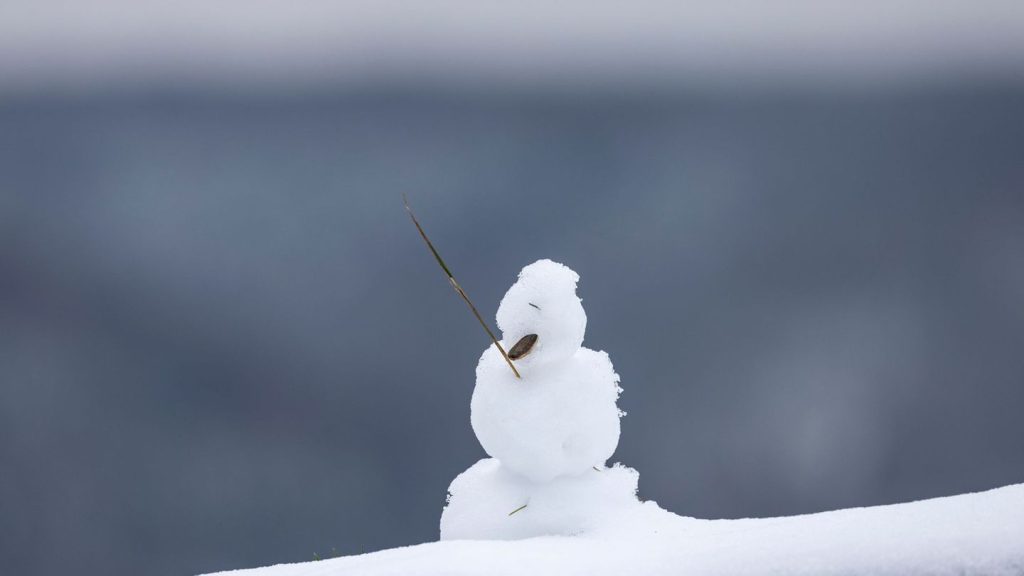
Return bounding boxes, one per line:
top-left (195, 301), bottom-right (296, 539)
top-left (440, 260), bottom-right (639, 540)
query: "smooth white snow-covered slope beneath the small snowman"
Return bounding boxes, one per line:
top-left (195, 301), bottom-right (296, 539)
top-left (205, 484), bottom-right (1024, 576)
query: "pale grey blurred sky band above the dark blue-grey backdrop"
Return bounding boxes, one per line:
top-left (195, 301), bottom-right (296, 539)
top-left (0, 0), bottom-right (1024, 89)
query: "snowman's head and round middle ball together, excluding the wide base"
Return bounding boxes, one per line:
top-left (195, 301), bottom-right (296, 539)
top-left (471, 259), bottom-right (621, 483)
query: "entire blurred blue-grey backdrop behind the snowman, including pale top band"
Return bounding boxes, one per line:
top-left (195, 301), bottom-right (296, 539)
top-left (0, 0), bottom-right (1024, 575)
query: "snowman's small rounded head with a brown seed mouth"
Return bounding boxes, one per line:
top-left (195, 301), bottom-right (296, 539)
top-left (498, 260), bottom-right (587, 372)
